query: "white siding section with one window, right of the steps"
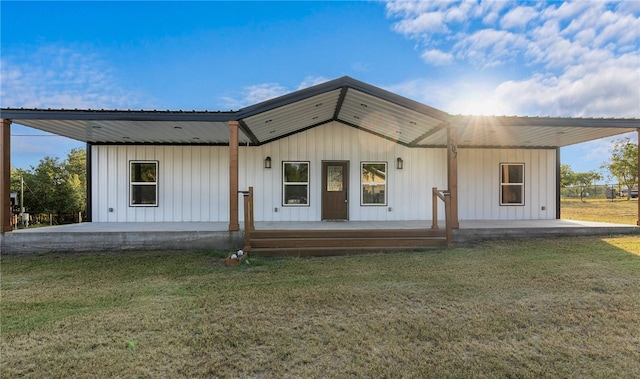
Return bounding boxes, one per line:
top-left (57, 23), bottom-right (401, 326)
top-left (458, 149), bottom-right (556, 221)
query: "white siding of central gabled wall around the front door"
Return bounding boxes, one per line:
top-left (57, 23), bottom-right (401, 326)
top-left (239, 122), bottom-right (447, 226)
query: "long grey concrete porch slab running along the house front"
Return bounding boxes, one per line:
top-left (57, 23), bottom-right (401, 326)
top-left (0, 220), bottom-right (640, 255)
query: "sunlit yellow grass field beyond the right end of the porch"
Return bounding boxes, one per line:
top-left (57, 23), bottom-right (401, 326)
top-left (560, 198), bottom-right (638, 225)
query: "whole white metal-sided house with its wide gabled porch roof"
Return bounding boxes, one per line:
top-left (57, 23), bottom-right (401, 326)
top-left (1, 77), bottom-right (640, 252)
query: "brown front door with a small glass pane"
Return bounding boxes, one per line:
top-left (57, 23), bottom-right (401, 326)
top-left (322, 161), bottom-right (349, 220)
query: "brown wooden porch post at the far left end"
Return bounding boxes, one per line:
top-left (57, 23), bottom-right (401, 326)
top-left (0, 119), bottom-right (11, 233)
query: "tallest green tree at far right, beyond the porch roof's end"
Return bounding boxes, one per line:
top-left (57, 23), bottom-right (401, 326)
top-left (602, 138), bottom-right (638, 199)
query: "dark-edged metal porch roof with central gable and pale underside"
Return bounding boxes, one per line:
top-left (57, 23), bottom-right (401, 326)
top-left (0, 76), bottom-right (640, 148)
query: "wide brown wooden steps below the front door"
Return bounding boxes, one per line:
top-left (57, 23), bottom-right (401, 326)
top-left (249, 228), bottom-right (447, 256)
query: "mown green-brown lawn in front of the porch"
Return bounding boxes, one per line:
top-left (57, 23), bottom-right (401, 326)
top-left (0, 236), bottom-right (640, 378)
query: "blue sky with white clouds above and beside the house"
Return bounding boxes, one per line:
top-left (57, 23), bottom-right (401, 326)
top-left (0, 0), bottom-right (640, 179)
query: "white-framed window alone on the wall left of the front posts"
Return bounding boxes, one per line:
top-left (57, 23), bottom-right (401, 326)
top-left (129, 161), bottom-right (158, 207)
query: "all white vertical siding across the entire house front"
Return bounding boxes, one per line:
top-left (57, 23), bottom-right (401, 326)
top-left (91, 122), bottom-right (556, 223)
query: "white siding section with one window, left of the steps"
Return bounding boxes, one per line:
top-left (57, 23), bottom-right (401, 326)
top-left (91, 145), bottom-right (229, 222)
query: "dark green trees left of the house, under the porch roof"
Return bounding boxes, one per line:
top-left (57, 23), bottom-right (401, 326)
top-left (11, 149), bottom-right (87, 223)
